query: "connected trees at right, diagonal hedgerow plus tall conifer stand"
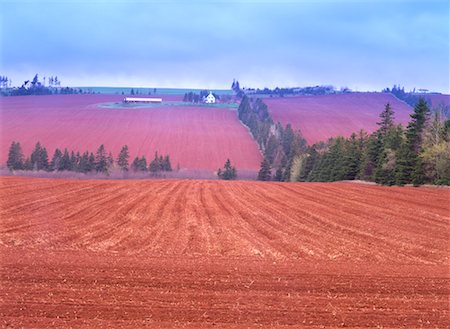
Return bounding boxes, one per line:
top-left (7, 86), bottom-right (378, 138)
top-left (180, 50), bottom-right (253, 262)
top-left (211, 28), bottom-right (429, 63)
top-left (248, 96), bottom-right (450, 186)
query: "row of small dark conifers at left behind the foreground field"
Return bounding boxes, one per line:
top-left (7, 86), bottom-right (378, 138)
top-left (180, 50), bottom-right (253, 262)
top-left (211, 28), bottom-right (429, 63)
top-left (6, 141), bottom-right (172, 174)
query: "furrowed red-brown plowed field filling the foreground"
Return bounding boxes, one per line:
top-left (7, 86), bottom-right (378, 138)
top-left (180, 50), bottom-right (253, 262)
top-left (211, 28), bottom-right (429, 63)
top-left (0, 177), bottom-right (450, 328)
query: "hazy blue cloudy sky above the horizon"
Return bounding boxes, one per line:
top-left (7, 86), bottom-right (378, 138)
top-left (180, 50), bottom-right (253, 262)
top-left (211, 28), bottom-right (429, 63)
top-left (0, 0), bottom-right (450, 93)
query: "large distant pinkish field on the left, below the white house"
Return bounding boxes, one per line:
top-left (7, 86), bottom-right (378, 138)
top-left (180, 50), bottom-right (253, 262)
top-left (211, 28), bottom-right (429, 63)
top-left (0, 95), bottom-right (261, 170)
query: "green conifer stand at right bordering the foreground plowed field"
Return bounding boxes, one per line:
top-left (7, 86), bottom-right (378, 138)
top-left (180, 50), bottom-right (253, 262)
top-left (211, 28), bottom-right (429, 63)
top-left (258, 98), bottom-right (450, 186)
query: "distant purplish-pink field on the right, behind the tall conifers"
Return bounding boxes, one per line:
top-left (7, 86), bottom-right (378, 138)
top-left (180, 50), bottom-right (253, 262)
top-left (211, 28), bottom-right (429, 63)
top-left (264, 93), bottom-right (412, 144)
